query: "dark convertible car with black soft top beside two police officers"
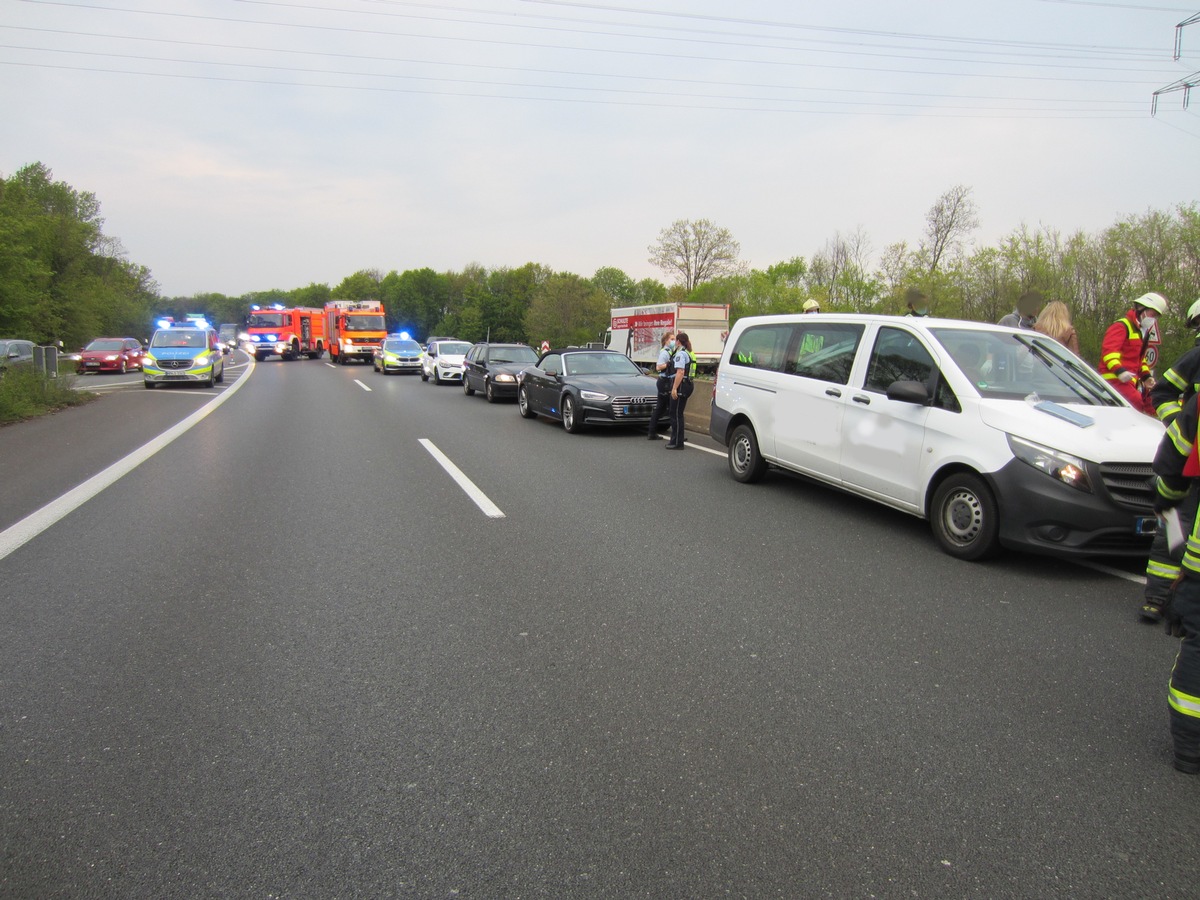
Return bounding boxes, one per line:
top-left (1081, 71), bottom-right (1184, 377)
top-left (517, 348), bottom-right (658, 434)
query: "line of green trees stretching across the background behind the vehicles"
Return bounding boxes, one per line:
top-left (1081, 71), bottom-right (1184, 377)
top-left (0, 163), bottom-right (1200, 369)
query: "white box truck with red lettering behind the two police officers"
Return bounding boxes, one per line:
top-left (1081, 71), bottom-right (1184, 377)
top-left (604, 304), bottom-right (730, 372)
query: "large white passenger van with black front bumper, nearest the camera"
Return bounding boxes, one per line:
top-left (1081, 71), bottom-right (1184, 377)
top-left (709, 314), bottom-right (1163, 559)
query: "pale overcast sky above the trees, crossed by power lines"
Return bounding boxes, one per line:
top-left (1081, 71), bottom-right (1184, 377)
top-left (0, 0), bottom-right (1200, 295)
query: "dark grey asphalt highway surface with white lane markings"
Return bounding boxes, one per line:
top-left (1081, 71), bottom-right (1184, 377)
top-left (0, 360), bottom-right (1200, 898)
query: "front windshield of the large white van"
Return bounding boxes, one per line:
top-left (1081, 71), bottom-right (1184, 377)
top-left (932, 328), bottom-right (1120, 406)
